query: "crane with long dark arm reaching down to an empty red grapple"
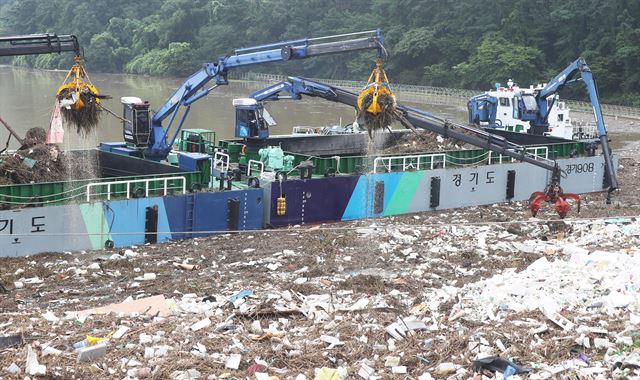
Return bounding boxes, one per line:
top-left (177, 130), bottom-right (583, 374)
top-left (234, 77), bottom-right (580, 218)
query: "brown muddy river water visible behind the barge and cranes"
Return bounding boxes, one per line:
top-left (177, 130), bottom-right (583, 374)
top-left (0, 66), bottom-right (466, 149)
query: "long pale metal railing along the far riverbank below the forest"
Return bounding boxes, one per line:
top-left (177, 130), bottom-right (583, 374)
top-left (236, 73), bottom-right (640, 119)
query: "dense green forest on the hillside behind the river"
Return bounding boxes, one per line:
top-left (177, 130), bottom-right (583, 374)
top-left (0, 0), bottom-right (640, 106)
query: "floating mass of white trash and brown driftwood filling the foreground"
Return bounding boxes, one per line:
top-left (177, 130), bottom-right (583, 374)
top-left (0, 204), bottom-right (640, 379)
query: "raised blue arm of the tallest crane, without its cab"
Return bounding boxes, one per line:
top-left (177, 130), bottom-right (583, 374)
top-left (147, 29), bottom-right (385, 157)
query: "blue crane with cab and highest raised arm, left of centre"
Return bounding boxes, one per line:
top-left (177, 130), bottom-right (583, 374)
top-left (122, 29), bottom-right (384, 160)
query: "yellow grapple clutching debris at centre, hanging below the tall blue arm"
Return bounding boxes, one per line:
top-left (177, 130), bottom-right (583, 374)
top-left (358, 58), bottom-right (396, 137)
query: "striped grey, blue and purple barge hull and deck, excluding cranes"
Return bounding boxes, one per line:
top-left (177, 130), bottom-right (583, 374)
top-left (0, 121), bottom-right (617, 256)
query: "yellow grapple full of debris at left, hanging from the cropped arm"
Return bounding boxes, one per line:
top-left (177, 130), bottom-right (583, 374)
top-left (56, 56), bottom-right (107, 133)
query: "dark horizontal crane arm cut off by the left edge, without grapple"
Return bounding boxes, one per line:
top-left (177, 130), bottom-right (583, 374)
top-left (0, 33), bottom-right (80, 57)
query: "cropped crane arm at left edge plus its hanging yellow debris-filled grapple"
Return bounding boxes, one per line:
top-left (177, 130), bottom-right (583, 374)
top-left (0, 33), bottom-right (105, 132)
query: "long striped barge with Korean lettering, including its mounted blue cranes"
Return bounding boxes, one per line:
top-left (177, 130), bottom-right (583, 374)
top-left (0, 30), bottom-right (617, 256)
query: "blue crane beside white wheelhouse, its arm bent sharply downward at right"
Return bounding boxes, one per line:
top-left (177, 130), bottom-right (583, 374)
top-left (468, 57), bottom-right (618, 197)
